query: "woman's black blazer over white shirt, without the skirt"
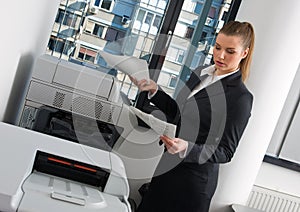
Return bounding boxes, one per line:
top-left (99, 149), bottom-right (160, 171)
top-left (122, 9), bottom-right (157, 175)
top-left (151, 66), bottom-right (253, 164)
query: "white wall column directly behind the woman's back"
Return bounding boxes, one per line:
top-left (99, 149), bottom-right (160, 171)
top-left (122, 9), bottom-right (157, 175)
top-left (211, 0), bottom-right (300, 212)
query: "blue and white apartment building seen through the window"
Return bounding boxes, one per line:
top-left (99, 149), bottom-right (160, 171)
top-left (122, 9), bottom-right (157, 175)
top-left (47, 0), bottom-right (236, 100)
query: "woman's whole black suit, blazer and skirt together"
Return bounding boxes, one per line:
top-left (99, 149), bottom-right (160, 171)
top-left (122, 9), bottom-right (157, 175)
top-left (138, 68), bottom-right (253, 212)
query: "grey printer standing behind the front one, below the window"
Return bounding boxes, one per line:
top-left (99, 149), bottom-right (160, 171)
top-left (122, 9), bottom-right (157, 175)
top-left (15, 54), bottom-right (164, 203)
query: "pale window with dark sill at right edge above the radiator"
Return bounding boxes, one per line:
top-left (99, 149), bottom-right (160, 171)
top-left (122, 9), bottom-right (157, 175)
top-left (264, 65), bottom-right (300, 172)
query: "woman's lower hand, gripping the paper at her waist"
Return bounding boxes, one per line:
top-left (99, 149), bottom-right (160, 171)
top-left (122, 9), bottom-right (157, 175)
top-left (160, 135), bottom-right (188, 154)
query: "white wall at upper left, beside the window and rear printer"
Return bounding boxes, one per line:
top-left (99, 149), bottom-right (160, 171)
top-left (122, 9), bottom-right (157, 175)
top-left (0, 0), bottom-right (60, 121)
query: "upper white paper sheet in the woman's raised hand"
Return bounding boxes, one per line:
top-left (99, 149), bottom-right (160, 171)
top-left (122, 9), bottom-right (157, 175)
top-left (99, 50), bottom-right (150, 82)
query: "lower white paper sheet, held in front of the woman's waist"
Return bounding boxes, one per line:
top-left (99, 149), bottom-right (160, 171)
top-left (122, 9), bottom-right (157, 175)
top-left (130, 106), bottom-right (176, 138)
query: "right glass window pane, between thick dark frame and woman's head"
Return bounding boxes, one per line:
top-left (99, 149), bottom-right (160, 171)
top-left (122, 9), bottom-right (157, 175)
top-left (158, 0), bottom-right (231, 96)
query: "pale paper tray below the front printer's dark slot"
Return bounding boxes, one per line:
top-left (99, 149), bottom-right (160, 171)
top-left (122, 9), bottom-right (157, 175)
top-left (18, 172), bottom-right (128, 212)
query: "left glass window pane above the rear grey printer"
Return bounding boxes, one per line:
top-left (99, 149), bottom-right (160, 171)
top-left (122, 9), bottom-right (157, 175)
top-left (47, 0), bottom-right (169, 101)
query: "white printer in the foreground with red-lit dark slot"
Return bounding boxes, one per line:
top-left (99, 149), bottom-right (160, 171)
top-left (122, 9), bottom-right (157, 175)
top-left (0, 122), bottom-right (131, 212)
